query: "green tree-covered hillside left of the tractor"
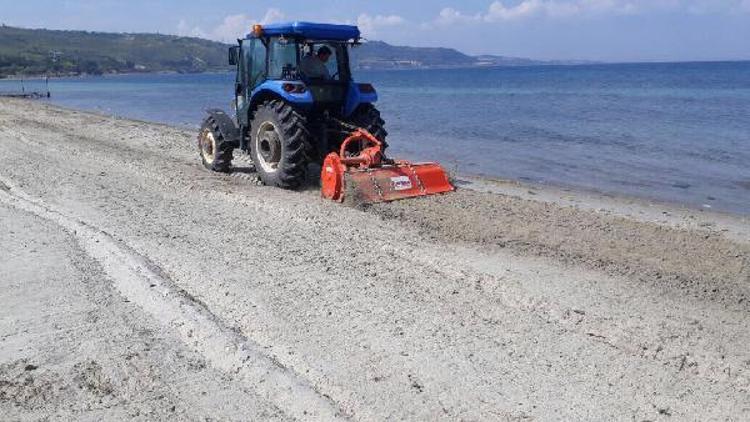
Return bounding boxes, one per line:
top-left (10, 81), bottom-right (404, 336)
top-left (0, 26), bottom-right (227, 75)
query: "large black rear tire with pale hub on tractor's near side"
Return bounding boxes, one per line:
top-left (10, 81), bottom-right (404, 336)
top-left (250, 100), bottom-right (310, 189)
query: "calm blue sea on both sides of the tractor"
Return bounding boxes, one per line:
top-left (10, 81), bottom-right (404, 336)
top-left (0, 62), bottom-right (750, 214)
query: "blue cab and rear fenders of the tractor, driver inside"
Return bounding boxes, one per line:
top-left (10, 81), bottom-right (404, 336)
top-left (230, 22), bottom-right (377, 121)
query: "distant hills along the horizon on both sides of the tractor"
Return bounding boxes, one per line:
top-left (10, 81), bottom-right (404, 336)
top-left (0, 26), bottom-right (588, 77)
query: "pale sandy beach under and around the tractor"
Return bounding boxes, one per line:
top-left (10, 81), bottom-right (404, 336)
top-left (0, 99), bottom-right (750, 421)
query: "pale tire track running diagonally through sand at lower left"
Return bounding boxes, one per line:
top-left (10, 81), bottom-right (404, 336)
top-left (0, 177), bottom-right (349, 420)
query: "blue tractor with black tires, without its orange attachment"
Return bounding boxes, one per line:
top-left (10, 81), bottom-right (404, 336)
top-left (198, 22), bottom-right (387, 189)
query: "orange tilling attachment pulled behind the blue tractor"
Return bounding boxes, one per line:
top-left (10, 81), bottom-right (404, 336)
top-left (320, 128), bottom-right (454, 203)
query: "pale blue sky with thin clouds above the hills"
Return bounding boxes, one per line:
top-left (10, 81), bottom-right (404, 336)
top-left (0, 0), bottom-right (750, 62)
